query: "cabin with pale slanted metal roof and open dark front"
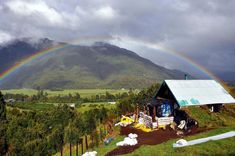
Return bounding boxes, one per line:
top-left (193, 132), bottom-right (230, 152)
top-left (147, 80), bottom-right (235, 119)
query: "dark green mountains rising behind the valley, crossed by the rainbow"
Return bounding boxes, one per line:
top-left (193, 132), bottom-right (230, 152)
top-left (0, 39), bottom-right (187, 89)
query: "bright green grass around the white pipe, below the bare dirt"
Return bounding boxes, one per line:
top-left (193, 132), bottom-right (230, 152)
top-left (126, 126), bottom-right (235, 156)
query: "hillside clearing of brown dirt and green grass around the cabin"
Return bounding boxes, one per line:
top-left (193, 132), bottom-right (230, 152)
top-left (96, 105), bottom-right (235, 156)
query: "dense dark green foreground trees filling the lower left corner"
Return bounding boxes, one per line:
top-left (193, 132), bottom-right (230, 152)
top-left (0, 90), bottom-right (116, 155)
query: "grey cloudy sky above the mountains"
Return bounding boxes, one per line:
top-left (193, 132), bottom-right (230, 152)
top-left (0, 0), bottom-right (235, 80)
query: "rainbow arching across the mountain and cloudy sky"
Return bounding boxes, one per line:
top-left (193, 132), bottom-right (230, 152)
top-left (0, 36), bottom-right (227, 88)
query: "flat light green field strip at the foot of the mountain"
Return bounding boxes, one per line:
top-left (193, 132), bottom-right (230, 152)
top-left (1, 89), bottom-right (128, 97)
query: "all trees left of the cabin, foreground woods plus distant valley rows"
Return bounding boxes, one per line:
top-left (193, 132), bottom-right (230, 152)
top-left (0, 84), bottom-right (160, 155)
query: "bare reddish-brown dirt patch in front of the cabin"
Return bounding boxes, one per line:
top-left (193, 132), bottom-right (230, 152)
top-left (106, 126), bottom-right (206, 156)
